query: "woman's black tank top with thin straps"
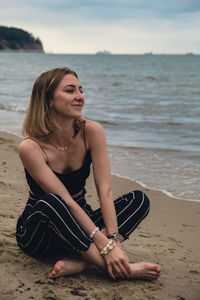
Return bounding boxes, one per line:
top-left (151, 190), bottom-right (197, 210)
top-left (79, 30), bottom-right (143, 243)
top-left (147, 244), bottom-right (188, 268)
top-left (25, 150), bottom-right (91, 196)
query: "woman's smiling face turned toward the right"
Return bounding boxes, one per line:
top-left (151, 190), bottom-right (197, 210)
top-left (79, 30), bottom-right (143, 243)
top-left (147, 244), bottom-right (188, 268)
top-left (50, 74), bottom-right (84, 118)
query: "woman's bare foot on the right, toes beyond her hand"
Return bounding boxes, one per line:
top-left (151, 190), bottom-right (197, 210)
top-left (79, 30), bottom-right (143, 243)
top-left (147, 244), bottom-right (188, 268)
top-left (131, 262), bottom-right (161, 280)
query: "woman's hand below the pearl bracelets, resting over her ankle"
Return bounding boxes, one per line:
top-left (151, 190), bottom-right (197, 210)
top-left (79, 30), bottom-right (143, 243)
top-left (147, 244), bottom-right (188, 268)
top-left (104, 242), bottom-right (131, 280)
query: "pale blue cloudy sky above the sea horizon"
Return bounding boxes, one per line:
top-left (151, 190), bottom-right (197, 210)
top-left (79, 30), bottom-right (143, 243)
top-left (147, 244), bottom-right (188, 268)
top-left (0, 0), bottom-right (200, 54)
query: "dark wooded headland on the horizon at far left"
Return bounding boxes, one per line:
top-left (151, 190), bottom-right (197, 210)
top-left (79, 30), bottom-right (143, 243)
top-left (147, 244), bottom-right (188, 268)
top-left (0, 26), bottom-right (43, 51)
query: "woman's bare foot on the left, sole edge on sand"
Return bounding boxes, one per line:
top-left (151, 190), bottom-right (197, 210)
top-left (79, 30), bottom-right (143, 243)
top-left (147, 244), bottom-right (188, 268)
top-left (49, 259), bottom-right (89, 278)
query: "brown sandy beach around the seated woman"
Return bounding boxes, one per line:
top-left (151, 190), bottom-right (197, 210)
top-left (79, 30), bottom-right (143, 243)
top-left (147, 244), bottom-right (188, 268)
top-left (0, 132), bottom-right (200, 300)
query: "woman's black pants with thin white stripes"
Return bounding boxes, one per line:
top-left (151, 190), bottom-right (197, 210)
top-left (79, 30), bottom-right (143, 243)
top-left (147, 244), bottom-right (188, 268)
top-left (16, 190), bottom-right (150, 256)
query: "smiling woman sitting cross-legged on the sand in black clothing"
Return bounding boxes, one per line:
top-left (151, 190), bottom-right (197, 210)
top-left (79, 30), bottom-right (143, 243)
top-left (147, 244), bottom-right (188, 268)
top-left (16, 68), bottom-right (161, 280)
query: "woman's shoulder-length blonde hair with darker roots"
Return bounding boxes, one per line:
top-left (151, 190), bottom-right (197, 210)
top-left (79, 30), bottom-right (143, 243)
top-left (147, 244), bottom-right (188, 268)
top-left (22, 68), bottom-right (79, 137)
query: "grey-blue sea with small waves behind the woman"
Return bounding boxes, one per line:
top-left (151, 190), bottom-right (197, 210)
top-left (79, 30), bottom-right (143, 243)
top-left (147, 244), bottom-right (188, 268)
top-left (0, 52), bottom-right (200, 201)
